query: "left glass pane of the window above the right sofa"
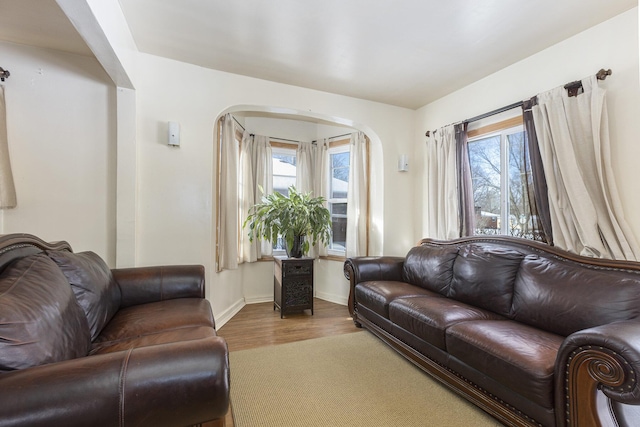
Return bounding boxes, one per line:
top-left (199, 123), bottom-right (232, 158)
top-left (469, 135), bottom-right (501, 234)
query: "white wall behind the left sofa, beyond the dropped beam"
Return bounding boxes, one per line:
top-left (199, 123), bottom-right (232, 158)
top-left (0, 42), bottom-right (116, 265)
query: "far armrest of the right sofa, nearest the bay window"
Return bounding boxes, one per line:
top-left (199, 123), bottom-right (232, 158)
top-left (344, 256), bottom-right (405, 316)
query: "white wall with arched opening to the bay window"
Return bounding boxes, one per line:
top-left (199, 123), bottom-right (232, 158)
top-left (136, 54), bottom-right (415, 321)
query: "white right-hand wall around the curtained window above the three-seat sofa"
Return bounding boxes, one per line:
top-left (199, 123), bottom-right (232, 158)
top-left (414, 8), bottom-right (640, 241)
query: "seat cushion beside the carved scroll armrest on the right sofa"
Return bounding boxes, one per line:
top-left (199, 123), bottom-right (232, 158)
top-left (446, 320), bottom-right (564, 408)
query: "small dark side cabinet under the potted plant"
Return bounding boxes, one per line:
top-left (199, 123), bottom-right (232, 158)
top-left (273, 257), bottom-right (313, 318)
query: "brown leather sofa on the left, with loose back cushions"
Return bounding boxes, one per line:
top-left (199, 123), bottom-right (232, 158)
top-left (0, 234), bottom-right (229, 427)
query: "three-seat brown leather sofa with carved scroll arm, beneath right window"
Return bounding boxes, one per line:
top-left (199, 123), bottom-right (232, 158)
top-left (344, 237), bottom-right (640, 427)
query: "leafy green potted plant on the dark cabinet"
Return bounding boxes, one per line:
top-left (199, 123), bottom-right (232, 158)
top-left (243, 186), bottom-right (331, 258)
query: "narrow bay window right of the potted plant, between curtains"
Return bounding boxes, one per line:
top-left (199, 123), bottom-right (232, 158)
top-left (327, 141), bottom-right (350, 255)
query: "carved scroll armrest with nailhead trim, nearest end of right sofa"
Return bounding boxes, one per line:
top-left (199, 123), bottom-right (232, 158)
top-left (555, 320), bottom-right (640, 426)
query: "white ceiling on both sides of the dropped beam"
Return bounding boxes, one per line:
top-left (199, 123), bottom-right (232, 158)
top-left (0, 0), bottom-right (637, 108)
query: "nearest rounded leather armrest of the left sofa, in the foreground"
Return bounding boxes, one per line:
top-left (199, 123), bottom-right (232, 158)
top-left (0, 336), bottom-right (229, 427)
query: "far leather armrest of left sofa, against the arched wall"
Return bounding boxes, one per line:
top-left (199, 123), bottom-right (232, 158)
top-left (111, 265), bottom-right (205, 307)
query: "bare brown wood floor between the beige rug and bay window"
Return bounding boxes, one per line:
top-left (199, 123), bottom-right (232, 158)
top-left (215, 298), bottom-right (362, 427)
